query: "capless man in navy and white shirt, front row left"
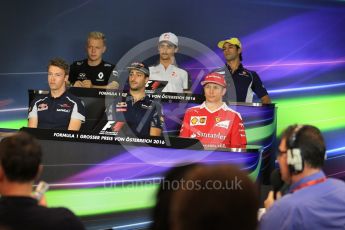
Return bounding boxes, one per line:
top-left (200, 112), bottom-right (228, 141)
top-left (28, 58), bottom-right (85, 130)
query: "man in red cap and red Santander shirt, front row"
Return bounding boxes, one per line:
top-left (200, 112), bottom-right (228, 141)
top-left (180, 73), bottom-right (247, 147)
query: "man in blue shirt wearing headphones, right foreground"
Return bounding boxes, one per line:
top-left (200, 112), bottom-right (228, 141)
top-left (260, 125), bottom-right (345, 229)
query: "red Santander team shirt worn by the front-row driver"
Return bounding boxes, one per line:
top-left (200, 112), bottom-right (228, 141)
top-left (180, 102), bottom-right (247, 147)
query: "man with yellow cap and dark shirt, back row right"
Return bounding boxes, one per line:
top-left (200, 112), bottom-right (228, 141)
top-left (215, 38), bottom-right (271, 104)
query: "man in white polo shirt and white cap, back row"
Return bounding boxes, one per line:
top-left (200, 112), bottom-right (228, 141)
top-left (149, 32), bottom-right (188, 93)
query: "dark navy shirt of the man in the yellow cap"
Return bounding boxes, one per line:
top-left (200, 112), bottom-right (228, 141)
top-left (214, 64), bottom-right (268, 103)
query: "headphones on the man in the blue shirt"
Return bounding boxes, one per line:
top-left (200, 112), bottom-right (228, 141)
top-left (287, 125), bottom-right (304, 174)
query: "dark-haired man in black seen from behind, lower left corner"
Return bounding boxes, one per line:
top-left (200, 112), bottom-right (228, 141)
top-left (0, 132), bottom-right (84, 230)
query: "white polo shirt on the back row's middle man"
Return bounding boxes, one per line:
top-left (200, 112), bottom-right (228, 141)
top-left (149, 64), bottom-right (188, 93)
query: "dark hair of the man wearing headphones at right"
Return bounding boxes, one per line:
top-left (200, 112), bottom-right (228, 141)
top-left (282, 125), bottom-right (326, 168)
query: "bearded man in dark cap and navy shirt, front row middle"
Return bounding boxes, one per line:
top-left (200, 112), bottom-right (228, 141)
top-left (103, 62), bottom-right (163, 136)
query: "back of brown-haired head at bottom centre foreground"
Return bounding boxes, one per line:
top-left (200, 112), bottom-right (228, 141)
top-left (170, 165), bottom-right (259, 230)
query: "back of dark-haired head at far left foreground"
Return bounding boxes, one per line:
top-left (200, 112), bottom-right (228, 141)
top-left (0, 132), bottom-right (42, 182)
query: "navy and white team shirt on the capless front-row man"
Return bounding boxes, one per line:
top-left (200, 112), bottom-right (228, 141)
top-left (28, 91), bottom-right (85, 130)
